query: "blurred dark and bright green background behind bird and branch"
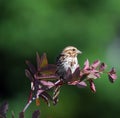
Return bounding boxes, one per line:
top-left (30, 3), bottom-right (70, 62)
top-left (0, 0), bottom-right (120, 118)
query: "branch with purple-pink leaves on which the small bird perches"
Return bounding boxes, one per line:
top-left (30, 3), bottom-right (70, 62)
top-left (21, 53), bottom-right (116, 113)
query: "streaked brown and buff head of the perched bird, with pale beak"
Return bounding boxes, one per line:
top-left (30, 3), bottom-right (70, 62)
top-left (62, 46), bottom-right (82, 57)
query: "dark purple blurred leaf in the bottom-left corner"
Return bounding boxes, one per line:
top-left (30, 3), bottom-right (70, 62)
top-left (0, 102), bottom-right (8, 118)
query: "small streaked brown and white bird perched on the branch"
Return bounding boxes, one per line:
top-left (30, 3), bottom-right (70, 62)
top-left (56, 46), bottom-right (82, 80)
